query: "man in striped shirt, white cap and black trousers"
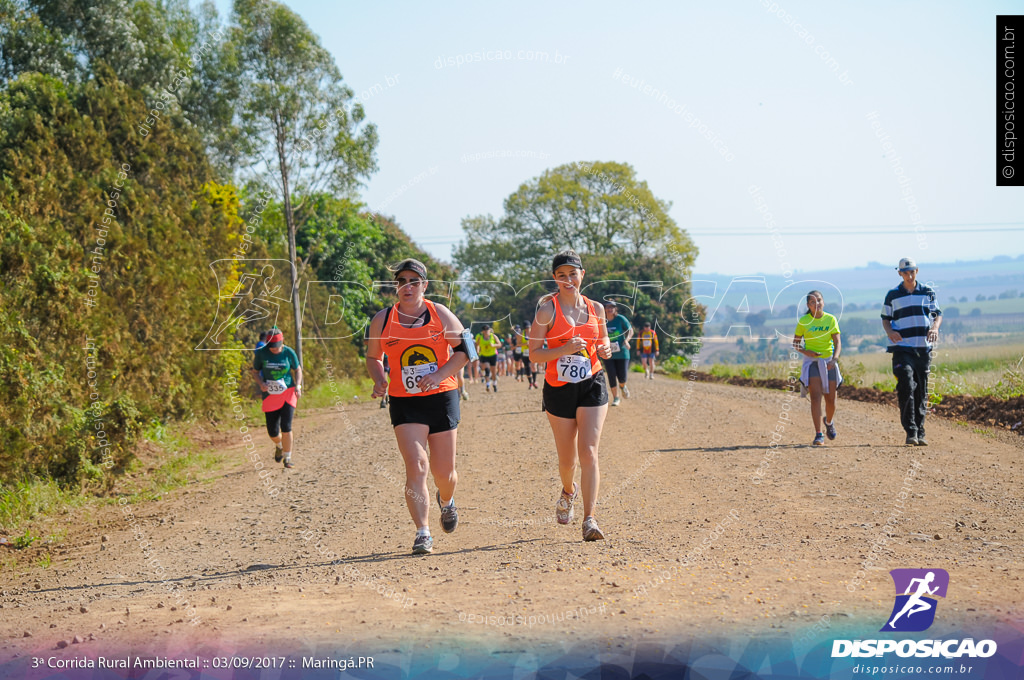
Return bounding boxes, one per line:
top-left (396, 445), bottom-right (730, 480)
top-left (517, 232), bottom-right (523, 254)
top-left (882, 257), bottom-right (942, 447)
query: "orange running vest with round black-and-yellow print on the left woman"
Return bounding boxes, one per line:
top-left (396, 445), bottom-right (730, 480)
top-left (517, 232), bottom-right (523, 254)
top-left (381, 300), bottom-right (459, 396)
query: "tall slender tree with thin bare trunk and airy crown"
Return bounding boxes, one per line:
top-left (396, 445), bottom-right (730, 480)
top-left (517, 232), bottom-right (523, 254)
top-left (230, 0), bottom-right (377, 360)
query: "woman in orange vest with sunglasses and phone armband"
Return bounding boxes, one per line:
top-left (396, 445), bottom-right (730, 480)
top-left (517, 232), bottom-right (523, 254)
top-left (367, 259), bottom-right (476, 555)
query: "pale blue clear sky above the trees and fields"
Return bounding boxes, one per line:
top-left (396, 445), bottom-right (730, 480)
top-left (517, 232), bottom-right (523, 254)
top-left (211, 0), bottom-right (1024, 274)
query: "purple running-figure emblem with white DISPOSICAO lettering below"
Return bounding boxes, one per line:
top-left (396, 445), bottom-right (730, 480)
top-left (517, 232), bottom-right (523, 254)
top-left (831, 569), bottom-right (996, 658)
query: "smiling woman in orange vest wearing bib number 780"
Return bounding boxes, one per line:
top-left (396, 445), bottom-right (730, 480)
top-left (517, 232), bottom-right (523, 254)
top-left (529, 250), bottom-right (611, 541)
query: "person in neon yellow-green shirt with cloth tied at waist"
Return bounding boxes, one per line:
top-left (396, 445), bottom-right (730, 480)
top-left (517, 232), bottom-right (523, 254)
top-left (793, 291), bottom-right (843, 447)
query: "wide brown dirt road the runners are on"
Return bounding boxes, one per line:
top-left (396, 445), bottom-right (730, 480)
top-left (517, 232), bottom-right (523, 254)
top-left (0, 376), bottom-right (1024, 661)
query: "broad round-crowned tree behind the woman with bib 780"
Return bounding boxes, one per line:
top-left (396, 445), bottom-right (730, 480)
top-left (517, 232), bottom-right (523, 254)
top-left (455, 162), bottom-right (705, 352)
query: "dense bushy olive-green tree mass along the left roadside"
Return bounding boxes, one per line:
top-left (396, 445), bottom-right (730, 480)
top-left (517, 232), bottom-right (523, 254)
top-left (0, 63), bottom-right (241, 482)
